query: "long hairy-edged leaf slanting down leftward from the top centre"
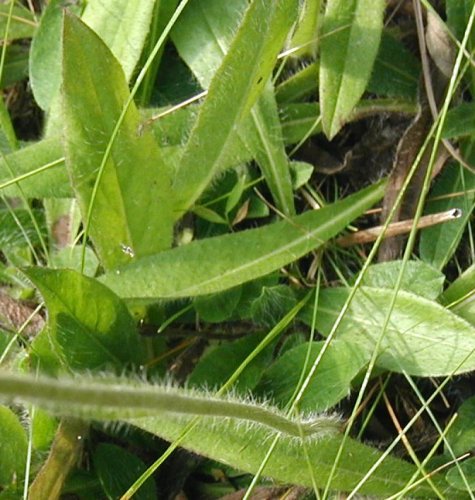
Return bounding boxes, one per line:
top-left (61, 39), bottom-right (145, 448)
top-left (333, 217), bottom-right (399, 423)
top-left (174, 0), bottom-right (298, 216)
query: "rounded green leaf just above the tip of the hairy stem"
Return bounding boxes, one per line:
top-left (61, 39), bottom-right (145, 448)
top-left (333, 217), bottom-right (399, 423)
top-left (256, 339), bottom-right (369, 413)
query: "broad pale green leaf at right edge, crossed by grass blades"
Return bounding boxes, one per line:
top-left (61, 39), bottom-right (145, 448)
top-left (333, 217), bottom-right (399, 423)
top-left (303, 287), bottom-right (475, 377)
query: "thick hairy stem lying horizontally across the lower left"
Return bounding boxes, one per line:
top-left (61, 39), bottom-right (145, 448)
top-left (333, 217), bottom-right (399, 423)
top-left (0, 372), bottom-right (340, 437)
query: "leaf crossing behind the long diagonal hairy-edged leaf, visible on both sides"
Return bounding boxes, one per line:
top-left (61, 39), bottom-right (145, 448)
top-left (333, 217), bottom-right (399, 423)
top-left (172, 0), bottom-right (298, 215)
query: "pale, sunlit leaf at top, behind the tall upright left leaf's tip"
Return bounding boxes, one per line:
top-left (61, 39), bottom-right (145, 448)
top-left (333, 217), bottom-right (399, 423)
top-left (82, 0), bottom-right (155, 81)
